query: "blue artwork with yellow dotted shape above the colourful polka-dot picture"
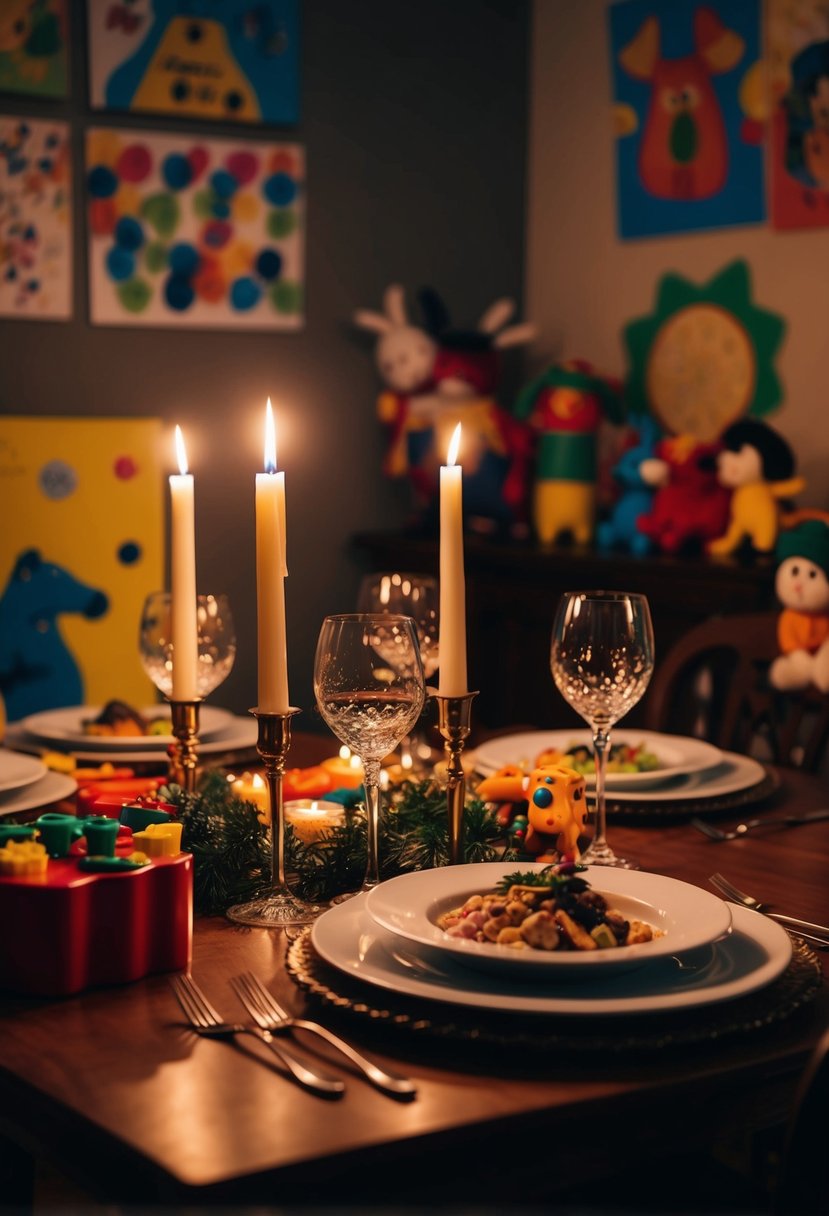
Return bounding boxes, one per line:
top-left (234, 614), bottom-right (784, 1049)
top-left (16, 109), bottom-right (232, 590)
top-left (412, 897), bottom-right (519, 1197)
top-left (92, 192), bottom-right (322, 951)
top-left (88, 0), bottom-right (299, 124)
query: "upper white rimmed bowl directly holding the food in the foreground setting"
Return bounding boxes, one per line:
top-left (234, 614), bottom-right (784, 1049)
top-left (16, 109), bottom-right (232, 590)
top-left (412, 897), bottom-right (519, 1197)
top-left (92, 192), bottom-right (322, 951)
top-left (366, 861), bottom-right (731, 979)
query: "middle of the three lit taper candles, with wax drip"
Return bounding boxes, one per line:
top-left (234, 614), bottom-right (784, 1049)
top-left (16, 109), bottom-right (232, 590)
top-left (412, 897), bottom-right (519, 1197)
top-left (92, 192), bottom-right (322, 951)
top-left (256, 398), bottom-right (291, 714)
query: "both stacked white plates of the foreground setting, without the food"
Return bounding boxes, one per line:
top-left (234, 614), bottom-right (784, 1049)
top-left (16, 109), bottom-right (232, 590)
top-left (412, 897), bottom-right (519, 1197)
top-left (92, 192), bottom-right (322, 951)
top-left (311, 862), bottom-right (791, 1017)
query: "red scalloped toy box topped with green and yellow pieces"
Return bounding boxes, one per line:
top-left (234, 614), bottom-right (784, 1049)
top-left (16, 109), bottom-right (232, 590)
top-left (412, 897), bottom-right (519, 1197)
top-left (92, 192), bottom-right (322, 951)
top-left (0, 804), bottom-right (193, 997)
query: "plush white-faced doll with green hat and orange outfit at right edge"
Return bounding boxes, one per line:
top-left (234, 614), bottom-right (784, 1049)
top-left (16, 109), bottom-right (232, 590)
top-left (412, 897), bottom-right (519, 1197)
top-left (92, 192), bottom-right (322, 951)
top-left (768, 517), bottom-right (829, 692)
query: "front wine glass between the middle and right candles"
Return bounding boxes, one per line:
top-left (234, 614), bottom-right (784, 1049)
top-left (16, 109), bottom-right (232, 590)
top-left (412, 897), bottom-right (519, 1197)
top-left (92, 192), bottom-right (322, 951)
top-left (314, 613), bottom-right (425, 902)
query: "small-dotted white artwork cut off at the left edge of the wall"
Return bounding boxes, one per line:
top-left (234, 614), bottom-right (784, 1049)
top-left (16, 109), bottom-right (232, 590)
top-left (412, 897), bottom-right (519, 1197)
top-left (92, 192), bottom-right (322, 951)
top-left (0, 114), bottom-right (72, 321)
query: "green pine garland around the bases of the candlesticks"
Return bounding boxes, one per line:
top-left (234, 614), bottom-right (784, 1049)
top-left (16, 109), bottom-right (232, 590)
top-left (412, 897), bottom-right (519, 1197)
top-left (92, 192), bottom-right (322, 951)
top-left (159, 771), bottom-right (520, 916)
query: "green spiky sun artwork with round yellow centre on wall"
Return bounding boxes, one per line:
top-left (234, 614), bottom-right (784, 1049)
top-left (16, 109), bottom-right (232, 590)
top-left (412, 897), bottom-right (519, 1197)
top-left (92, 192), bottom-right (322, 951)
top-left (624, 260), bottom-right (785, 443)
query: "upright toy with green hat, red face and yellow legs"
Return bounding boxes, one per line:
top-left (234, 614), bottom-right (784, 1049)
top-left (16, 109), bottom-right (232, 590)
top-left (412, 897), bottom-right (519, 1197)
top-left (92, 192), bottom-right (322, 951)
top-left (513, 359), bottom-right (621, 545)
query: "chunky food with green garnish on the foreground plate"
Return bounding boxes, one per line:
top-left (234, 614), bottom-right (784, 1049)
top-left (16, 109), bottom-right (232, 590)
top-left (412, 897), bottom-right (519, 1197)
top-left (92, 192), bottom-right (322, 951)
top-left (438, 862), bottom-right (662, 951)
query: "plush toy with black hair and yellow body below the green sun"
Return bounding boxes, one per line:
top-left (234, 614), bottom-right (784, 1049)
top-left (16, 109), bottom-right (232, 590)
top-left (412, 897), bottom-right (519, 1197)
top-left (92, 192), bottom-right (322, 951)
top-left (707, 418), bottom-right (806, 557)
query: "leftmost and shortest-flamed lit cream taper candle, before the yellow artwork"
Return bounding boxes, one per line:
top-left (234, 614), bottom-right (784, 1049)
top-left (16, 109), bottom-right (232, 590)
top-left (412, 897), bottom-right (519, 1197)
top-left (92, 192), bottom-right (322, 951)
top-left (170, 427), bottom-right (198, 700)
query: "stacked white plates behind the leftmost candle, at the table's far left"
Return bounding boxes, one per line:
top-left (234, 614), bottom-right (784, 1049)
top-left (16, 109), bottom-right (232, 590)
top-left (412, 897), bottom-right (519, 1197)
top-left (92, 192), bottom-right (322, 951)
top-left (6, 705), bottom-right (256, 764)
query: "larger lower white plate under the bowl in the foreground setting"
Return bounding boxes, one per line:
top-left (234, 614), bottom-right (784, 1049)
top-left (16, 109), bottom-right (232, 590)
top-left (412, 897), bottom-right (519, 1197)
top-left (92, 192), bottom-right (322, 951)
top-left (311, 895), bottom-right (791, 1017)
